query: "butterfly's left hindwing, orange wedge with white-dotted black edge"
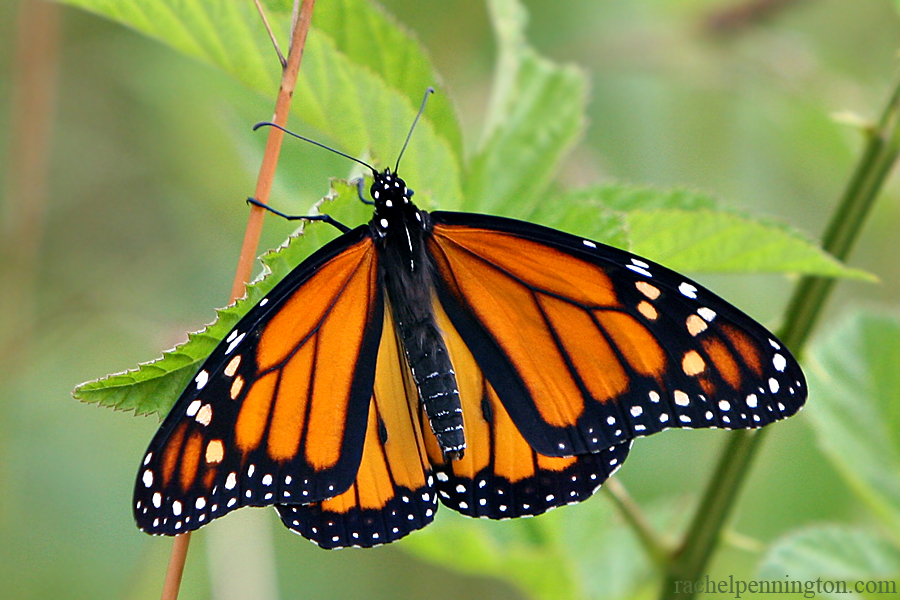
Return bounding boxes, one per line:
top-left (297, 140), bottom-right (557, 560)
top-left (277, 310), bottom-right (437, 548)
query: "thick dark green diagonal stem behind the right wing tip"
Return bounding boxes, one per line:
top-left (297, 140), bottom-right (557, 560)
top-left (661, 75), bottom-right (900, 600)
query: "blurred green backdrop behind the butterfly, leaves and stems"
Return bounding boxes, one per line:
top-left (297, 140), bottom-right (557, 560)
top-left (0, 0), bottom-right (900, 599)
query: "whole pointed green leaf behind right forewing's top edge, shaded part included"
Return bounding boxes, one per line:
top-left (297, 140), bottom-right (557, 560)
top-left (529, 184), bottom-right (872, 280)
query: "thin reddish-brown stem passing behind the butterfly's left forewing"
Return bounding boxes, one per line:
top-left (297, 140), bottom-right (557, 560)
top-left (162, 0), bottom-right (316, 600)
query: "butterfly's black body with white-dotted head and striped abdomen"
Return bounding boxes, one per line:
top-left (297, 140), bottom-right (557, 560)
top-left (370, 169), bottom-right (466, 459)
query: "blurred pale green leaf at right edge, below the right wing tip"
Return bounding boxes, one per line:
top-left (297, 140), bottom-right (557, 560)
top-left (806, 311), bottom-right (900, 539)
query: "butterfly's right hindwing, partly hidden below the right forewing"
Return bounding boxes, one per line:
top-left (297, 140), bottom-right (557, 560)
top-left (426, 303), bottom-right (631, 519)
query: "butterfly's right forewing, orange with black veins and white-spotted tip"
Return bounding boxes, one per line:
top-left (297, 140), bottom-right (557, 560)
top-left (429, 212), bottom-right (806, 456)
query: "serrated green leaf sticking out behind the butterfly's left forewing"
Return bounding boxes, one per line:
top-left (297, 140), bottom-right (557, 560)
top-left (73, 181), bottom-right (368, 416)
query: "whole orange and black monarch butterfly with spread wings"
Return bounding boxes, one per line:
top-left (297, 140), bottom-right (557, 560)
top-left (133, 94), bottom-right (806, 548)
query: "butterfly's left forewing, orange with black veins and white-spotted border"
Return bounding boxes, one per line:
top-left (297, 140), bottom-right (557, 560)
top-left (133, 227), bottom-right (384, 535)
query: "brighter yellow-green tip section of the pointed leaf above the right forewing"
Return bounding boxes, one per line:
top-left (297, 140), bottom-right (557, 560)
top-left (626, 209), bottom-right (874, 281)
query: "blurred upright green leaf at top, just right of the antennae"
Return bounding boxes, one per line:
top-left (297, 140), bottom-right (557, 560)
top-left (464, 0), bottom-right (587, 217)
